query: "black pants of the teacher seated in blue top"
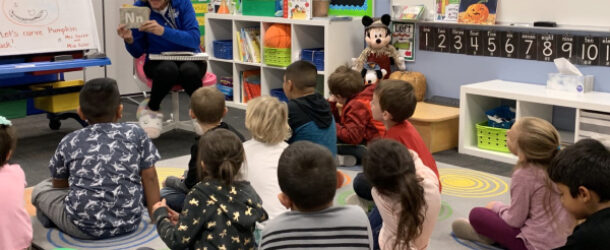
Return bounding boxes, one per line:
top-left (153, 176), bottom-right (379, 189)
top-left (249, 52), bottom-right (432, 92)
top-left (144, 60), bottom-right (207, 111)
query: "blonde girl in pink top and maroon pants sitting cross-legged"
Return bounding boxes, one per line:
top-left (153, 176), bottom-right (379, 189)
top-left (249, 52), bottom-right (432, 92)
top-left (452, 117), bottom-right (574, 249)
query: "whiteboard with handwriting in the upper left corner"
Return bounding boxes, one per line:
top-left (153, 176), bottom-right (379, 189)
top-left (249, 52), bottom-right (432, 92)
top-left (0, 0), bottom-right (101, 56)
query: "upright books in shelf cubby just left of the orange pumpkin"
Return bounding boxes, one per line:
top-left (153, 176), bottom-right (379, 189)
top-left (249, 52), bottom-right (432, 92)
top-left (235, 27), bottom-right (261, 63)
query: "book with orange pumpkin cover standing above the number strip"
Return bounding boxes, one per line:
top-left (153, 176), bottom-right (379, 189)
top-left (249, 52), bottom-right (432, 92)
top-left (458, 0), bottom-right (498, 25)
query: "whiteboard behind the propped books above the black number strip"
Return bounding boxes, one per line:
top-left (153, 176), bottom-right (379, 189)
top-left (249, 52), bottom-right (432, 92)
top-left (388, 0), bottom-right (610, 27)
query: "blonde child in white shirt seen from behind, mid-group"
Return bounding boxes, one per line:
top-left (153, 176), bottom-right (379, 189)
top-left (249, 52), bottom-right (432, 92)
top-left (244, 96), bottom-right (290, 223)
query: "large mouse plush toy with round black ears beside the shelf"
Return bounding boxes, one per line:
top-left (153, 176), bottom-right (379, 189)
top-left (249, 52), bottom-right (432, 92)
top-left (353, 14), bottom-right (406, 79)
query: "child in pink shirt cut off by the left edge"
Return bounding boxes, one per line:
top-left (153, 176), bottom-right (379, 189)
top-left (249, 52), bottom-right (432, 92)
top-left (0, 116), bottom-right (32, 249)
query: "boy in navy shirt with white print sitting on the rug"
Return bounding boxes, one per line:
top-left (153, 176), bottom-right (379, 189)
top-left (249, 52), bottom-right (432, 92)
top-left (32, 78), bottom-right (160, 239)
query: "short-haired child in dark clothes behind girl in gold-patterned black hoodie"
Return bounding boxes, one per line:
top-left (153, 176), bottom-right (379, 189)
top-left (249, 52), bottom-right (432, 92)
top-left (161, 87), bottom-right (244, 212)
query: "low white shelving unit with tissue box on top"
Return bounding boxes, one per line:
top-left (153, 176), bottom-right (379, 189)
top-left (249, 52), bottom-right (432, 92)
top-left (459, 80), bottom-right (610, 164)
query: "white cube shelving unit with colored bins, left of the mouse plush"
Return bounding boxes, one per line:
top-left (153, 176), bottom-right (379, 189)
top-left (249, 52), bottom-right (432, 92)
top-left (205, 14), bottom-right (364, 109)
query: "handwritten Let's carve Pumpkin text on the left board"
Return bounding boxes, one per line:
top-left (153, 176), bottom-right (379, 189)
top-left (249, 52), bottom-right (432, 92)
top-left (0, 25), bottom-right (91, 49)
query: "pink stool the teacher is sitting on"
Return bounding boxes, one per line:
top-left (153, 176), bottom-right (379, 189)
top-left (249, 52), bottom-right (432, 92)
top-left (134, 55), bottom-right (217, 134)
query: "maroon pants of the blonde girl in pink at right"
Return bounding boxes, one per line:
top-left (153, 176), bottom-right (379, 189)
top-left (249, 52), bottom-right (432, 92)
top-left (469, 207), bottom-right (527, 250)
